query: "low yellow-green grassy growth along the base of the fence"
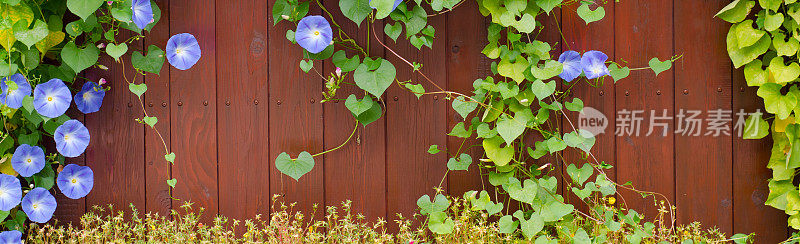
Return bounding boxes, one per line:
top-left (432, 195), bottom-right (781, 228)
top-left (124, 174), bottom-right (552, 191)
top-left (27, 197), bottom-right (744, 244)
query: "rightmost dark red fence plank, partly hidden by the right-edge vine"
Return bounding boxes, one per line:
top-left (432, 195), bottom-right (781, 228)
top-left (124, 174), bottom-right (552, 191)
top-left (732, 30), bottom-right (790, 243)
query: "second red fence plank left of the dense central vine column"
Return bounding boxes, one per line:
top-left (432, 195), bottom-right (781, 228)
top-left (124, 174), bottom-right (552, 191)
top-left (383, 15), bottom-right (450, 220)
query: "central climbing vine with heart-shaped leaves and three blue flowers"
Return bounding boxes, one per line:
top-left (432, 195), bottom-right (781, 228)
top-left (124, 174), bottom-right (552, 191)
top-left (272, 0), bottom-right (748, 243)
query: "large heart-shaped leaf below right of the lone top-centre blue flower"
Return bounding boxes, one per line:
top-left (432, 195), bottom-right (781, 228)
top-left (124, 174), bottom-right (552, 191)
top-left (353, 59), bottom-right (397, 97)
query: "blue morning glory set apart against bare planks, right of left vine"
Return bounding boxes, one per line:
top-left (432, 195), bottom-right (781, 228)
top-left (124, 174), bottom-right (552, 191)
top-left (167, 33), bottom-right (202, 70)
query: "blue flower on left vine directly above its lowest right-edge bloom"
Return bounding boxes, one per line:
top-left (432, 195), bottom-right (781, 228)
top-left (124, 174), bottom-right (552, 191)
top-left (53, 119), bottom-right (90, 158)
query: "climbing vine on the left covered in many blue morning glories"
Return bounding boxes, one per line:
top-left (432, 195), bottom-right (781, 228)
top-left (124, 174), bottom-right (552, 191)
top-left (0, 0), bottom-right (201, 238)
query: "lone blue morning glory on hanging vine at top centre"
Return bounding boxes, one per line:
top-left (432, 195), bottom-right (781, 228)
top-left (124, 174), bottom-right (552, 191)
top-left (294, 15), bottom-right (333, 53)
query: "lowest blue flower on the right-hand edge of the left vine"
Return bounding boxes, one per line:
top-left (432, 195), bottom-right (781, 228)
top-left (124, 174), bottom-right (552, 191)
top-left (56, 164), bottom-right (94, 199)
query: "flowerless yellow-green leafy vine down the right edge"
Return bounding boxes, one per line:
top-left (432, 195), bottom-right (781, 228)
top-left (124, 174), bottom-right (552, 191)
top-left (716, 0), bottom-right (800, 230)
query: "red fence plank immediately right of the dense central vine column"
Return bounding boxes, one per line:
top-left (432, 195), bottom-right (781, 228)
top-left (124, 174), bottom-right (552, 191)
top-left (614, 0), bottom-right (675, 221)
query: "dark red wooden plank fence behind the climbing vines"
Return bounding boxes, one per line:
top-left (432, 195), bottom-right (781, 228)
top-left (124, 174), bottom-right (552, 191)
top-left (53, 0), bottom-right (788, 243)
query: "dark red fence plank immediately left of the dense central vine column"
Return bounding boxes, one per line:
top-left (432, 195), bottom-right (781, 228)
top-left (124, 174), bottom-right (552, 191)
top-left (446, 0), bottom-right (492, 196)
